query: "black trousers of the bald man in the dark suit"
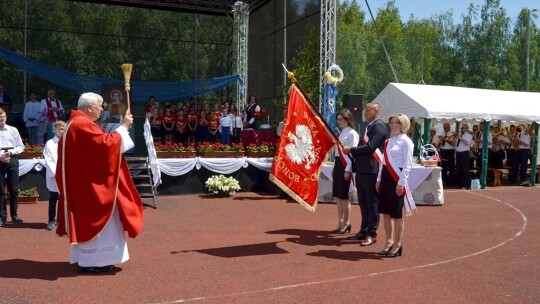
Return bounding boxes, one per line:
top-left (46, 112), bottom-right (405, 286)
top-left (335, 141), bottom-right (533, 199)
top-left (356, 173), bottom-right (379, 237)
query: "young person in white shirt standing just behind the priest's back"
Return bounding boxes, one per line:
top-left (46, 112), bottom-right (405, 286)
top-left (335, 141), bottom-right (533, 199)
top-left (43, 120), bottom-right (66, 230)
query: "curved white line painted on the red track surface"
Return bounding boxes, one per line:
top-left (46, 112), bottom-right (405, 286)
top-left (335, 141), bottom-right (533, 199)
top-left (154, 191), bottom-right (527, 304)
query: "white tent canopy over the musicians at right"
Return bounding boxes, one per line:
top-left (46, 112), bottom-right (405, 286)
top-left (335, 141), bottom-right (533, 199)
top-left (373, 83), bottom-right (540, 123)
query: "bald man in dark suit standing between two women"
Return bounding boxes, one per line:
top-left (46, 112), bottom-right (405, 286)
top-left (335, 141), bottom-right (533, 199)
top-left (343, 103), bottom-right (388, 246)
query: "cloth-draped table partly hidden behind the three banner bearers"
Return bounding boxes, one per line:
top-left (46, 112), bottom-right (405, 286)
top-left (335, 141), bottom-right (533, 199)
top-left (318, 162), bottom-right (444, 205)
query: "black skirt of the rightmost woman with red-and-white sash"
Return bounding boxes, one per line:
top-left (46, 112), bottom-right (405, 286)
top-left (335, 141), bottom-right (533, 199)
top-left (379, 166), bottom-right (404, 218)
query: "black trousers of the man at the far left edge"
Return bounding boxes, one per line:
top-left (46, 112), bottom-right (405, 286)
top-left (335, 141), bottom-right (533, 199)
top-left (0, 157), bottom-right (19, 221)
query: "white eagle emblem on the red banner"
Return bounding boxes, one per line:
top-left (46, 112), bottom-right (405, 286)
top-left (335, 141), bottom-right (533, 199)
top-left (285, 125), bottom-right (315, 170)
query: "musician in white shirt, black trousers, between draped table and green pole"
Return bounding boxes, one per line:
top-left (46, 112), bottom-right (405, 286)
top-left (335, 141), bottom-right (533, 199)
top-left (455, 124), bottom-right (473, 189)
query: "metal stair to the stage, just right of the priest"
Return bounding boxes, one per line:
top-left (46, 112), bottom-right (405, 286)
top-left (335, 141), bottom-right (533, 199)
top-left (126, 157), bottom-right (157, 209)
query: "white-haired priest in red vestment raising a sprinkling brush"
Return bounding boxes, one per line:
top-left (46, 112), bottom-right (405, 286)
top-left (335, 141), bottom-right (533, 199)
top-left (55, 93), bottom-right (143, 273)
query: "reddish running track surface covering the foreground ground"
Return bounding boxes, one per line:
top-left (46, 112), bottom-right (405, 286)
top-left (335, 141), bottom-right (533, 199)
top-left (0, 187), bottom-right (540, 303)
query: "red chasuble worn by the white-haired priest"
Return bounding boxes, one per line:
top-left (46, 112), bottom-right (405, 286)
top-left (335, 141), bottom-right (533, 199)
top-left (55, 110), bottom-right (143, 244)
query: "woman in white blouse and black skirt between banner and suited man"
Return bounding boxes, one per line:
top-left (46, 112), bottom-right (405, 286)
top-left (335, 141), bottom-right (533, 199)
top-left (332, 109), bottom-right (360, 234)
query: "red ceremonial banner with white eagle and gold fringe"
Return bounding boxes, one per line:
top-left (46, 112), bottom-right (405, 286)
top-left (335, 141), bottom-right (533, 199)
top-left (270, 85), bottom-right (334, 211)
